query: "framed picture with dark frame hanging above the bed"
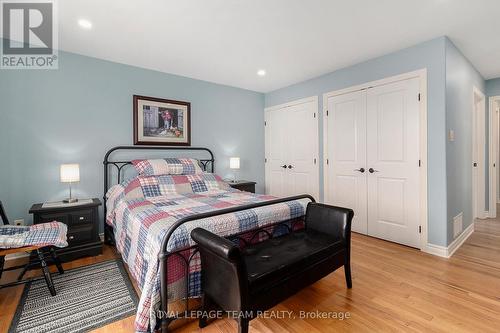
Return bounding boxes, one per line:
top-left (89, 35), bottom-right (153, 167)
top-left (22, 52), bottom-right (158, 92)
top-left (134, 95), bottom-right (191, 146)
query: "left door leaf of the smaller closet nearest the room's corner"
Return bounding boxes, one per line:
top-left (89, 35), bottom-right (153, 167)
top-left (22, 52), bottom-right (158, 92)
top-left (265, 109), bottom-right (288, 197)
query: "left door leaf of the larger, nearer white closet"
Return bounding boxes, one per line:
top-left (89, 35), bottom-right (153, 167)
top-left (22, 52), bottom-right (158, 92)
top-left (325, 91), bottom-right (367, 234)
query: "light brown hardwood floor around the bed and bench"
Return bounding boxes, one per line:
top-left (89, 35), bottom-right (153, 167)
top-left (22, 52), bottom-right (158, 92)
top-left (0, 215), bottom-right (500, 333)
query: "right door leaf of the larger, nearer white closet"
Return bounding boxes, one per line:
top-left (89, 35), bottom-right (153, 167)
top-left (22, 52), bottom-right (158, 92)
top-left (366, 78), bottom-right (420, 247)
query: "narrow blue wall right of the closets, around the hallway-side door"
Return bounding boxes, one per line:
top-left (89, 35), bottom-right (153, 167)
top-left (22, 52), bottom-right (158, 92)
top-left (446, 39), bottom-right (489, 244)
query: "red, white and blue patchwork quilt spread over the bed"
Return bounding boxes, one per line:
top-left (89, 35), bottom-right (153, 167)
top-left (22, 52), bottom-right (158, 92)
top-left (106, 173), bottom-right (309, 332)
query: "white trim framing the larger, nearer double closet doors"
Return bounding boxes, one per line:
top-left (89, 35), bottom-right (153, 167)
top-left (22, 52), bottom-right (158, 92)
top-left (323, 68), bottom-right (428, 252)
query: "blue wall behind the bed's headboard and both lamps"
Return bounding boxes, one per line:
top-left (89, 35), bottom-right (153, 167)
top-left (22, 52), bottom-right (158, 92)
top-left (0, 46), bottom-right (264, 230)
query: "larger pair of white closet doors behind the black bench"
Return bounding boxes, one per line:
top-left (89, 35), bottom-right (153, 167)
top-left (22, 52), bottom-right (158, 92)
top-left (325, 78), bottom-right (420, 248)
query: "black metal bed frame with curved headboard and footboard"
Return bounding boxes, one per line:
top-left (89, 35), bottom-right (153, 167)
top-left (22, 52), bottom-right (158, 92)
top-left (103, 146), bottom-right (315, 333)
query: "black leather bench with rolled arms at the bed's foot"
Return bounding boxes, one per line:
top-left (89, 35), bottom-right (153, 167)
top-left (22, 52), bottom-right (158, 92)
top-left (191, 203), bottom-right (354, 333)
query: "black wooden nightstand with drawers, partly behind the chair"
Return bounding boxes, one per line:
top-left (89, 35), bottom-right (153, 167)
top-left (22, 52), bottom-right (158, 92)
top-left (30, 199), bottom-right (102, 261)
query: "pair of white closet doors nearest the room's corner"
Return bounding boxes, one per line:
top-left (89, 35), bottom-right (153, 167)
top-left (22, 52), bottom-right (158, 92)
top-left (266, 100), bottom-right (319, 200)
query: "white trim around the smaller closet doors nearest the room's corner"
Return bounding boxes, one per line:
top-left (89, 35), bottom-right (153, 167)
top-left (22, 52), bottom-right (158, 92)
top-left (264, 96), bottom-right (320, 202)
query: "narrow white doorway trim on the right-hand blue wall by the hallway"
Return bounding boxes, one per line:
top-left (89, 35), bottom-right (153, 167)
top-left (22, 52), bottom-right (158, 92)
top-left (470, 86), bottom-right (488, 219)
